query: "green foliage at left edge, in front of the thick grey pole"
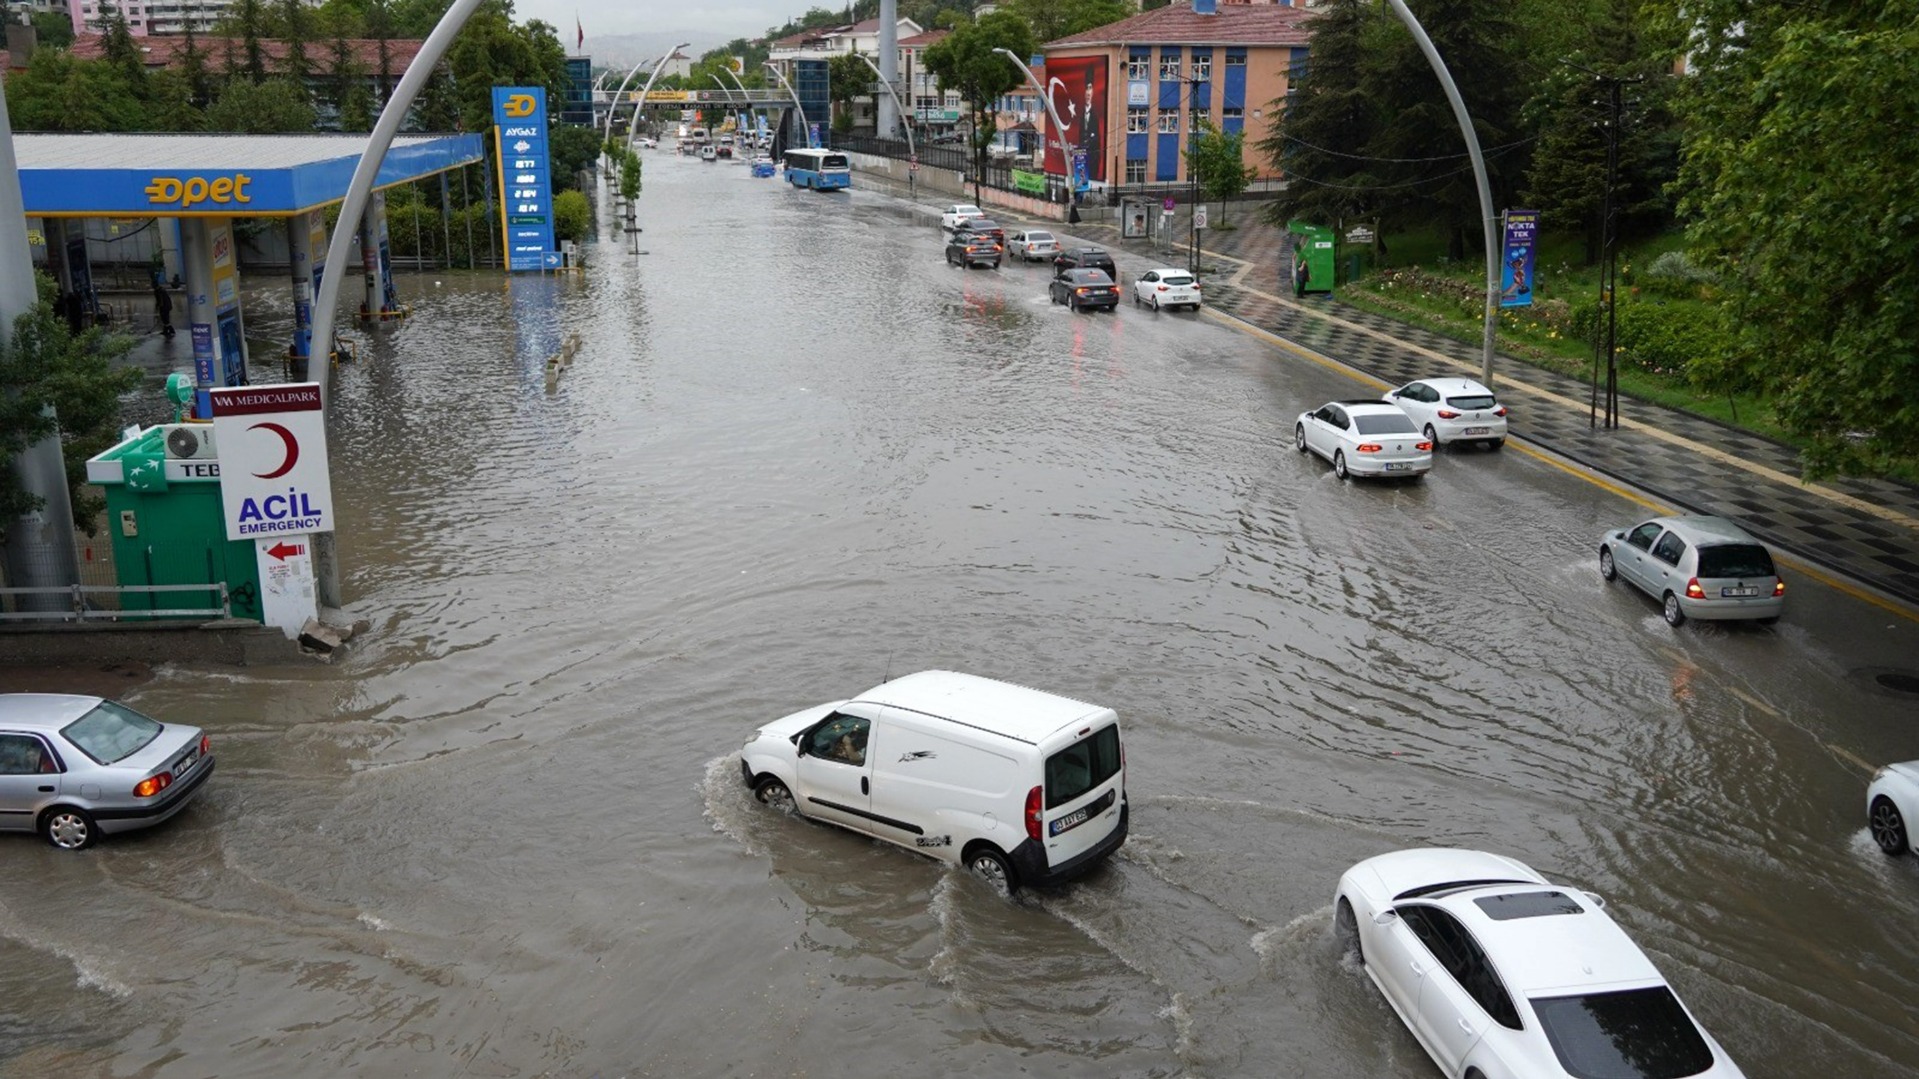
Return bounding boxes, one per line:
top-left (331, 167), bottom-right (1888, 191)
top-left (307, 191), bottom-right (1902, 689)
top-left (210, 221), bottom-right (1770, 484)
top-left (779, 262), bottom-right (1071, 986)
top-left (0, 275), bottom-right (140, 536)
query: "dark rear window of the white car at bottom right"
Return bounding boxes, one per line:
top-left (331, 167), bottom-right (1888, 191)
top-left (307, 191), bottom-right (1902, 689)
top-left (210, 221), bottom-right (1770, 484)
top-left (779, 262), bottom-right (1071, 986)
top-left (1533, 985), bottom-right (1712, 1079)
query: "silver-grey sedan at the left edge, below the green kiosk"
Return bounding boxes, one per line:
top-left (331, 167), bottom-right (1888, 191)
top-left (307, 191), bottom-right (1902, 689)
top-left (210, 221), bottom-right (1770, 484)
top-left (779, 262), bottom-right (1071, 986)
top-left (0, 693), bottom-right (213, 851)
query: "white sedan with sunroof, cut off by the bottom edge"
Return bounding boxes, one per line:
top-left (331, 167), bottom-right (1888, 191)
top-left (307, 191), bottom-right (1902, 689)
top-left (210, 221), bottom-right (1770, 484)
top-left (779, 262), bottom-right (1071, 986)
top-left (1334, 849), bottom-right (1742, 1079)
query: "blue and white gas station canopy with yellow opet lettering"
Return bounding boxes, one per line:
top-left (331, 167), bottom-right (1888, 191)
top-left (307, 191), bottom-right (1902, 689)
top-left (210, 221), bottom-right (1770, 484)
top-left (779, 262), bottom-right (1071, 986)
top-left (13, 132), bottom-right (484, 217)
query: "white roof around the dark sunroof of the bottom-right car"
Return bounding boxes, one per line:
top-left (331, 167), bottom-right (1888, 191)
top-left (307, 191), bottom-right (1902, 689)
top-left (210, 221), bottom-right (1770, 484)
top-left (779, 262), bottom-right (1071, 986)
top-left (1414, 885), bottom-right (1666, 996)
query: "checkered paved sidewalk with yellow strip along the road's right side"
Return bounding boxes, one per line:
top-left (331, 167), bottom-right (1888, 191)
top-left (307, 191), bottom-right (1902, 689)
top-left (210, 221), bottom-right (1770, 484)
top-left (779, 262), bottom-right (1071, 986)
top-left (1071, 211), bottom-right (1919, 607)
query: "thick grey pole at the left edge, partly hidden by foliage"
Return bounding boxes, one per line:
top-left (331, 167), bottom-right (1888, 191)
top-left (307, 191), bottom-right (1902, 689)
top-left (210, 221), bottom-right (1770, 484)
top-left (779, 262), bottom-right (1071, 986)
top-left (0, 75), bottom-right (79, 612)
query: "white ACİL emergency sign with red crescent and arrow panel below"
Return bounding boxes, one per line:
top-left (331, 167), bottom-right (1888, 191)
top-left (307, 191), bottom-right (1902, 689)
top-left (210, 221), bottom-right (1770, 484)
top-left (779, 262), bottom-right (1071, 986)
top-left (211, 382), bottom-right (334, 637)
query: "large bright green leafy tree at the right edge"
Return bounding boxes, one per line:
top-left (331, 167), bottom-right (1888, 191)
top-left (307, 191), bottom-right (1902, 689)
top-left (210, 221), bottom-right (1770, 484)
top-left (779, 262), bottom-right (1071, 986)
top-left (1677, 0), bottom-right (1919, 476)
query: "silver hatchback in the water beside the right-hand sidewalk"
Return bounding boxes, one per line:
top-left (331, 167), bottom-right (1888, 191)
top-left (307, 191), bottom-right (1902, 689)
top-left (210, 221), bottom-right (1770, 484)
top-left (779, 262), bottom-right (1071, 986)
top-left (1599, 516), bottom-right (1787, 626)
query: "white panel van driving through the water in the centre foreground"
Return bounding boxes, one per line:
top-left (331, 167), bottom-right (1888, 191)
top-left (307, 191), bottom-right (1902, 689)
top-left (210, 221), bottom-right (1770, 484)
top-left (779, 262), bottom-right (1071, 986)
top-left (739, 670), bottom-right (1128, 895)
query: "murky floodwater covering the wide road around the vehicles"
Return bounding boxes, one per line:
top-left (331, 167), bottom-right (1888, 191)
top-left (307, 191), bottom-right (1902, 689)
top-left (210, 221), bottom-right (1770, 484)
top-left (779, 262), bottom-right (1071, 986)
top-left (0, 146), bottom-right (1919, 1079)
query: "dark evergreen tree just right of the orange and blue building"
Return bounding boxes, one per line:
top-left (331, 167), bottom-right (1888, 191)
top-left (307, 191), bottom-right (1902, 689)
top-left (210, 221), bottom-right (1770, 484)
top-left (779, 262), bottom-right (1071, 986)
top-left (1259, 0), bottom-right (1380, 228)
